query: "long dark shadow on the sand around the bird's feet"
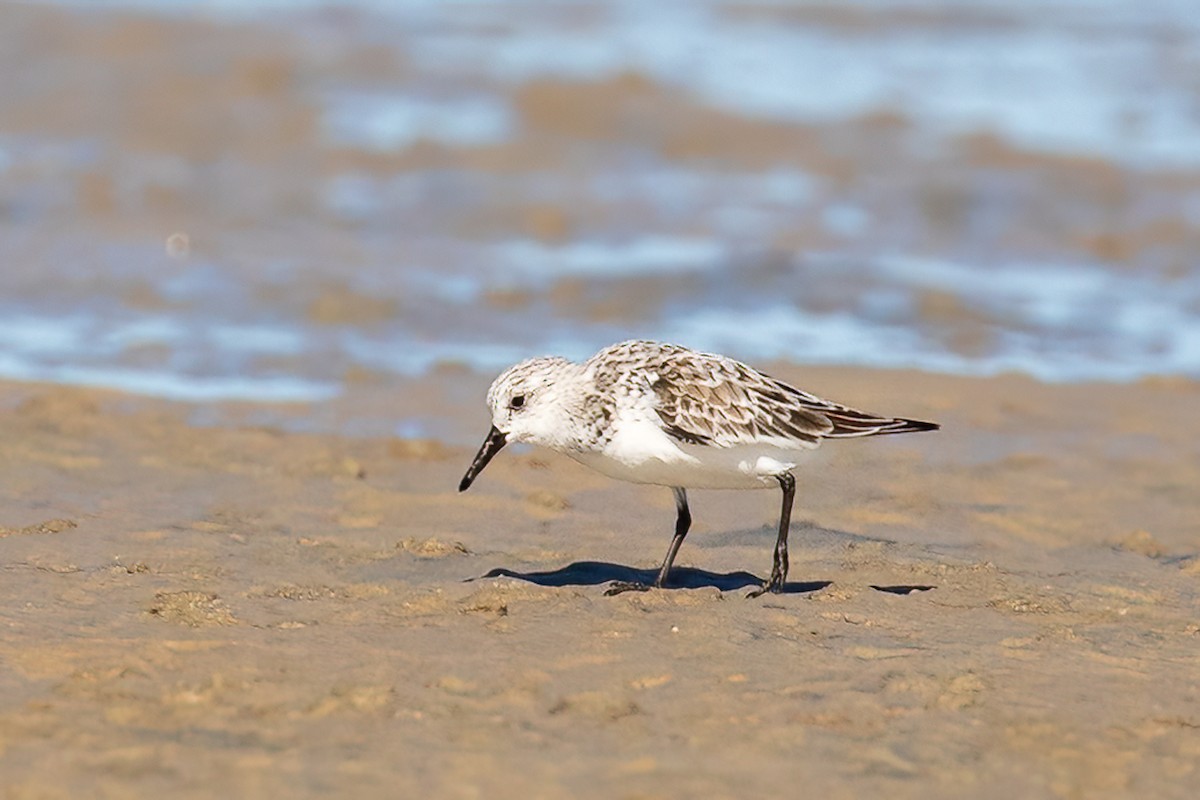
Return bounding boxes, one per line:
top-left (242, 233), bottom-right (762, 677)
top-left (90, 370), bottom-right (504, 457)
top-left (468, 561), bottom-right (833, 595)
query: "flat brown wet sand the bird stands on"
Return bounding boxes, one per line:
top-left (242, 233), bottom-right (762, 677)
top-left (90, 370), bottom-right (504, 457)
top-left (0, 366), bottom-right (1200, 798)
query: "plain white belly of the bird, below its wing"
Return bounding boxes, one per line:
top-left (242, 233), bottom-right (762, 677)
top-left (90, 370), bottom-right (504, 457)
top-left (569, 422), bottom-right (805, 489)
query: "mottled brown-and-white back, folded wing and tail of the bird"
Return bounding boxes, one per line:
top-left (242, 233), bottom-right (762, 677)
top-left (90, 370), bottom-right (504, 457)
top-left (592, 342), bottom-right (938, 447)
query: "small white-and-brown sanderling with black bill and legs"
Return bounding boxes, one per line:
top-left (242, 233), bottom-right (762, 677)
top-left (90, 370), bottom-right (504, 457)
top-left (458, 341), bottom-right (938, 597)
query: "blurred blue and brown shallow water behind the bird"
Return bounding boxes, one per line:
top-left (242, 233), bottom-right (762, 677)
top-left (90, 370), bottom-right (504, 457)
top-left (0, 0), bottom-right (1200, 441)
